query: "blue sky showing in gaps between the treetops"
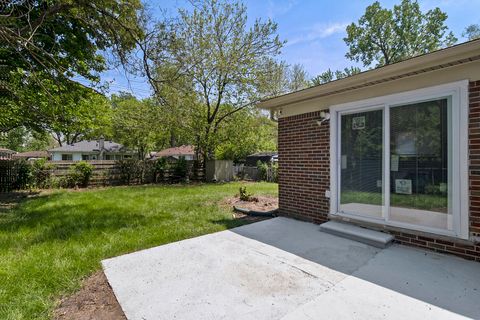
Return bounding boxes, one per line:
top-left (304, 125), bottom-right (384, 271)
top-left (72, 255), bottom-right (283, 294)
top-left (102, 0), bottom-right (480, 97)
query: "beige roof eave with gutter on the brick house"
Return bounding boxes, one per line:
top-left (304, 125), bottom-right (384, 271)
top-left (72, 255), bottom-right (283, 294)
top-left (258, 39), bottom-right (480, 109)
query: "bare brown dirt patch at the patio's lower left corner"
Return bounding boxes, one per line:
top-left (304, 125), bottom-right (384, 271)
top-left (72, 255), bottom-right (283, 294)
top-left (54, 271), bottom-right (126, 320)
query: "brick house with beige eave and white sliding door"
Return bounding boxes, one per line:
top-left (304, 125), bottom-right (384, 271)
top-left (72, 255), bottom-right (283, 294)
top-left (260, 40), bottom-right (480, 261)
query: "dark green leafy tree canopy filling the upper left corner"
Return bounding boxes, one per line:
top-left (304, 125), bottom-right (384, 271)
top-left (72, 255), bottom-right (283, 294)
top-left (0, 0), bottom-right (143, 132)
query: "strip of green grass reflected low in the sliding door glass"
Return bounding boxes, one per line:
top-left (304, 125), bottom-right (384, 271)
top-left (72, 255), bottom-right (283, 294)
top-left (341, 191), bottom-right (448, 212)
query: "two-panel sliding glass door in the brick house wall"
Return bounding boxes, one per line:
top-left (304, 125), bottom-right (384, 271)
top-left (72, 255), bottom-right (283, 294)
top-left (337, 97), bottom-right (453, 231)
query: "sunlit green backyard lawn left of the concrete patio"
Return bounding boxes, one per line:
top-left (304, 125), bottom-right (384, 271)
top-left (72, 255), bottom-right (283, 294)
top-left (0, 183), bottom-right (277, 319)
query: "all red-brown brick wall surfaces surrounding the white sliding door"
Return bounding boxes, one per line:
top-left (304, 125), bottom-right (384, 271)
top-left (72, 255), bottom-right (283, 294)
top-left (278, 81), bottom-right (480, 261)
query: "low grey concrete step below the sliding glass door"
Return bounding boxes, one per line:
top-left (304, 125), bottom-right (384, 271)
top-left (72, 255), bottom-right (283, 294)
top-left (320, 221), bottom-right (393, 248)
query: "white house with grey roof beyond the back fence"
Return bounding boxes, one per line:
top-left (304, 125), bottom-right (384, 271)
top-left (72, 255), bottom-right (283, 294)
top-left (48, 139), bottom-right (135, 161)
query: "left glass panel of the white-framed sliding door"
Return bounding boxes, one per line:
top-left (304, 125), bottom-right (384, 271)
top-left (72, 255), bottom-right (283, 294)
top-left (339, 109), bottom-right (385, 219)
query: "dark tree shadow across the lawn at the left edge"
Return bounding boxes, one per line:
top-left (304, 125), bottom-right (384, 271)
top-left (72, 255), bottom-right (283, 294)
top-left (0, 194), bottom-right (172, 248)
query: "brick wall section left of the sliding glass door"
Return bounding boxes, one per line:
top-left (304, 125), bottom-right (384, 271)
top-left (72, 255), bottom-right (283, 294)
top-left (278, 112), bottom-right (330, 223)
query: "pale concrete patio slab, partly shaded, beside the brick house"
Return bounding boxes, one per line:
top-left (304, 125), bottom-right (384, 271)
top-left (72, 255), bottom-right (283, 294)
top-left (103, 218), bottom-right (480, 320)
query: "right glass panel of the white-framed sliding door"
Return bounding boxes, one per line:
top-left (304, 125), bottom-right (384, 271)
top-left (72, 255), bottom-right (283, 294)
top-left (389, 98), bottom-right (453, 230)
